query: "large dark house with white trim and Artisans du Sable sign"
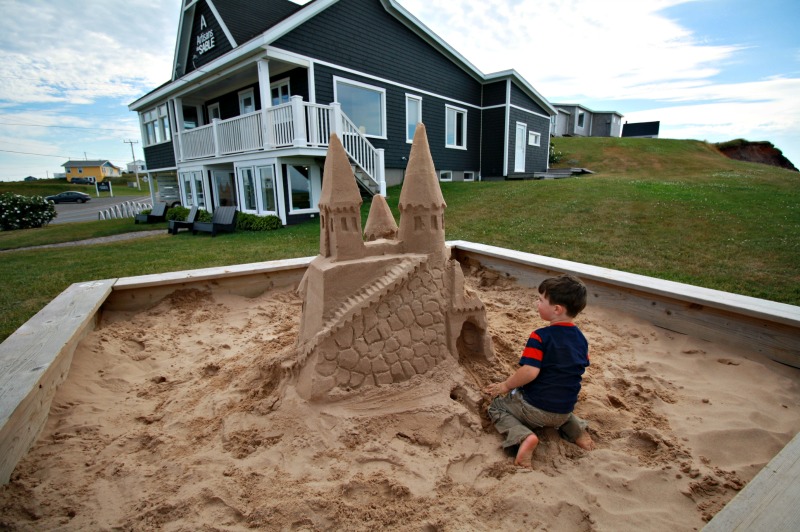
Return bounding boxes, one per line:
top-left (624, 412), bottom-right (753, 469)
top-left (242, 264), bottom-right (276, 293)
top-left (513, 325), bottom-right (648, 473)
top-left (129, 0), bottom-right (556, 224)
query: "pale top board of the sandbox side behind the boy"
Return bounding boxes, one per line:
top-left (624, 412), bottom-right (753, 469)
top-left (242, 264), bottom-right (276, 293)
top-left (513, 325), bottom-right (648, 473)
top-left (447, 240), bottom-right (800, 327)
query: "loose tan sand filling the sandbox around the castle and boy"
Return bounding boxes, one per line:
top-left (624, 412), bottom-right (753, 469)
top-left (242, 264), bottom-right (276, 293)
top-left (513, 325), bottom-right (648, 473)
top-left (0, 270), bottom-right (800, 531)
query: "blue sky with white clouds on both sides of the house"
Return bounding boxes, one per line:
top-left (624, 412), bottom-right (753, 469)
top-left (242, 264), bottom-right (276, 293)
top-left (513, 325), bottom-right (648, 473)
top-left (0, 0), bottom-right (800, 181)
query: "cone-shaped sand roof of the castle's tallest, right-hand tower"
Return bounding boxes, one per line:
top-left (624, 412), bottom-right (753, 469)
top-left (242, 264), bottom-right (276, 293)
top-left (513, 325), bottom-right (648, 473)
top-left (400, 123), bottom-right (447, 209)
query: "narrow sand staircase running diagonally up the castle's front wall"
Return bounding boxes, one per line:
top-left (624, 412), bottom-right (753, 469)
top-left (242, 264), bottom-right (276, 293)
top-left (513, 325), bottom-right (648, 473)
top-left (298, 255), bottom-right (428, 364)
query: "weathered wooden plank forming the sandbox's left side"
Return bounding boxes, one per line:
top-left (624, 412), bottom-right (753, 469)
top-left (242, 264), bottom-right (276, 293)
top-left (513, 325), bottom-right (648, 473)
top-left (0, 279), bottom-right (115, 484)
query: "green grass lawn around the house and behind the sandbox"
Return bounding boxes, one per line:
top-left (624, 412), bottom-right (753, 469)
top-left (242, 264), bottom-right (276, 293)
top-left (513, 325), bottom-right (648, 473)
top-left (0, 138), bottom-right (800, 339)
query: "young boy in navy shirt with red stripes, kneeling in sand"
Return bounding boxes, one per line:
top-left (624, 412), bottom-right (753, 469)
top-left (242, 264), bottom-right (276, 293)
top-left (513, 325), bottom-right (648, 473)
top-left (484, 275), bottom-right (594, 467)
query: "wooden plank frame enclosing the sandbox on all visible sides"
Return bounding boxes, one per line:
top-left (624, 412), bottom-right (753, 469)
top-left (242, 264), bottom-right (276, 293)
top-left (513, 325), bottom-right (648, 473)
top-left (0, 241), bottom-right (800, 531)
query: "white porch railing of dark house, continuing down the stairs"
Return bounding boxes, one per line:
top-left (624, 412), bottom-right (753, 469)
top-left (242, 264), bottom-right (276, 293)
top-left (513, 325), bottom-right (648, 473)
top-left (179, 96), bottom-right (386, 195)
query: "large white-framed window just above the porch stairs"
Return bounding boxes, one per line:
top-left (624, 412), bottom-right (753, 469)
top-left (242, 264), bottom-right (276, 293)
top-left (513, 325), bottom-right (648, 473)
top-left (333, 77), bottom-right (386, 138)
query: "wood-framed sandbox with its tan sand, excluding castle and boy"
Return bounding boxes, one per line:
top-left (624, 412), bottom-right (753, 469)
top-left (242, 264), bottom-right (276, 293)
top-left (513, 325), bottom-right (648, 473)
top-left (0, 241), bottom-right (800, 530)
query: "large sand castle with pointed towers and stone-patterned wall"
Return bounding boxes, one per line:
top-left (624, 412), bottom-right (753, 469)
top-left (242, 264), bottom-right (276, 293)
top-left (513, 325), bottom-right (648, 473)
top-left (297, 124), bottom-right (493, 400)
